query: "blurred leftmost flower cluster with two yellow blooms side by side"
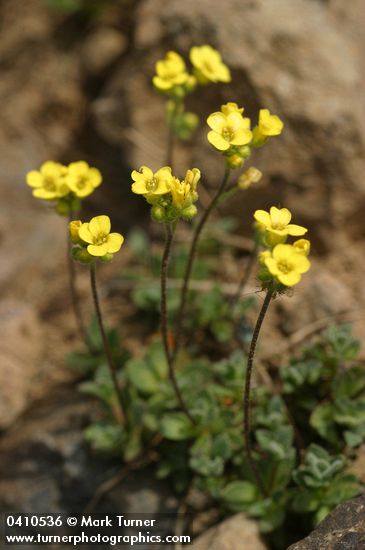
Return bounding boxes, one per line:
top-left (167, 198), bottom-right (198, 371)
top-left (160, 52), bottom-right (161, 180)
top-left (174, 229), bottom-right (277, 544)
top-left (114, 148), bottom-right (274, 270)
top-left (26, 160), bottom-right (102, 214)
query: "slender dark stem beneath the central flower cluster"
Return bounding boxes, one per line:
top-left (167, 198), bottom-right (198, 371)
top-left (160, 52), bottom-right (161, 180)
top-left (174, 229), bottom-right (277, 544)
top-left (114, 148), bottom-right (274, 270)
top-left (161, 224), bottom-right (196, 424)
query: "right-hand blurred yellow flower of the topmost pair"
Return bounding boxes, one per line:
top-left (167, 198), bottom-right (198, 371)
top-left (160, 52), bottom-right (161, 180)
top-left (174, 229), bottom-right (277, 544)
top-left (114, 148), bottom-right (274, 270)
top-left (190, 45), bottom-right (231, 84)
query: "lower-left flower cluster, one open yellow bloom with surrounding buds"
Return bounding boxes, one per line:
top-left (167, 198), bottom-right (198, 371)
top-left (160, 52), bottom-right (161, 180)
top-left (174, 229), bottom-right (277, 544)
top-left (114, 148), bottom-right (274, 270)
top-left (69, 216), bottom-right (124, 264)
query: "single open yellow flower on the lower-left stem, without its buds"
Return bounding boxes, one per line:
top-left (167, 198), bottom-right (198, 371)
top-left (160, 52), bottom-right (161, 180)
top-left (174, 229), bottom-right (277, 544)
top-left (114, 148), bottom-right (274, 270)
top-left (77, 216), bottom-right (124, 257)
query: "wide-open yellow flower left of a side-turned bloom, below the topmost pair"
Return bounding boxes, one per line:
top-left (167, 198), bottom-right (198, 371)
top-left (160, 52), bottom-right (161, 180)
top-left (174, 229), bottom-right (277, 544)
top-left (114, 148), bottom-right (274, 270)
top-left (207, 111), bottom-right (252, 151)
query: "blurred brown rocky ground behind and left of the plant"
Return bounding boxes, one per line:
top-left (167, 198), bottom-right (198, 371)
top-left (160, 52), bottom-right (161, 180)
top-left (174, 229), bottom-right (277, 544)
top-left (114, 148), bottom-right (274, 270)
top-left (0, 0), bottom-right (365, 550)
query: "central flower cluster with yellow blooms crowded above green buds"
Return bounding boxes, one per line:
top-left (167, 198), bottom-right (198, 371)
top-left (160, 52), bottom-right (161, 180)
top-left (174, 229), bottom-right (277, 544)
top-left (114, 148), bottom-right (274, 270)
top-left (132, 166), bottom-right (200, 222)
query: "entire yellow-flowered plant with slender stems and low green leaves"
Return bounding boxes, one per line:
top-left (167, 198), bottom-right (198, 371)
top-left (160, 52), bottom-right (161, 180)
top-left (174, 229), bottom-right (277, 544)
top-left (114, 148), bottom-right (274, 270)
top-left (27, 45), bottom-right (365, 548)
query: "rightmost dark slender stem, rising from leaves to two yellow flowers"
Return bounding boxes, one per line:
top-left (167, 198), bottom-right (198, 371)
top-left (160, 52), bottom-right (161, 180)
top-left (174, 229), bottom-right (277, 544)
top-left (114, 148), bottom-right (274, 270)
top-left (243, 290), bottom-right (274, 496)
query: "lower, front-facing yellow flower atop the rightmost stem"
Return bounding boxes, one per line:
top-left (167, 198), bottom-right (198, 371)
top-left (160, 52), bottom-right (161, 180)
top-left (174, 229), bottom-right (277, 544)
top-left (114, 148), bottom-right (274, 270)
top-left (264, 244), bottom-right (310, 286)
